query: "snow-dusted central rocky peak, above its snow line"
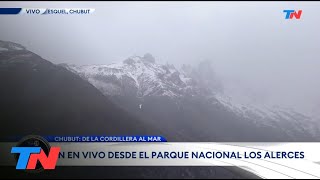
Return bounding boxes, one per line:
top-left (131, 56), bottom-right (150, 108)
top-left (65, 54), bottom-right (202, 98)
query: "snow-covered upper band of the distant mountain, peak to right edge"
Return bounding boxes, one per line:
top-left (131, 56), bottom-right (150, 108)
top-left (63, 54), bottom-right (320, 137)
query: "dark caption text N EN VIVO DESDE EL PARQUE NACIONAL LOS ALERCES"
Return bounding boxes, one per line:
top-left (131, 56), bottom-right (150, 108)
top-left (59, 151), bottom-right (305, 159)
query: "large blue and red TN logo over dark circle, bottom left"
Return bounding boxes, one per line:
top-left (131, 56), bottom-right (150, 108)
top-left (11, 136), bottom-right (60, 172)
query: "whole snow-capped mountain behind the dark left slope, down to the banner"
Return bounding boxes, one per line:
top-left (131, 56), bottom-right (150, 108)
top-left (61, 53), bottom-right (320, 141)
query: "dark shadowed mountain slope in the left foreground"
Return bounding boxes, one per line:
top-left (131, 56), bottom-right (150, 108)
top-left (0, 41), bottom-right (155, 135)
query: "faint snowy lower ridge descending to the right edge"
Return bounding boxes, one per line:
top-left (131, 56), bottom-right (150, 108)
top-left (215, 94), bottom-right (320, 137)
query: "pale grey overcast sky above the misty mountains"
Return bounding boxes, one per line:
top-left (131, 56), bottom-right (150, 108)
top-left (0, 2), bottom-right (320, 115)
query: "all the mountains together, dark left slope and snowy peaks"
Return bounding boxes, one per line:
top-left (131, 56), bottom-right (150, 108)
top-left (0, 41), bottom-right (320, 141)
